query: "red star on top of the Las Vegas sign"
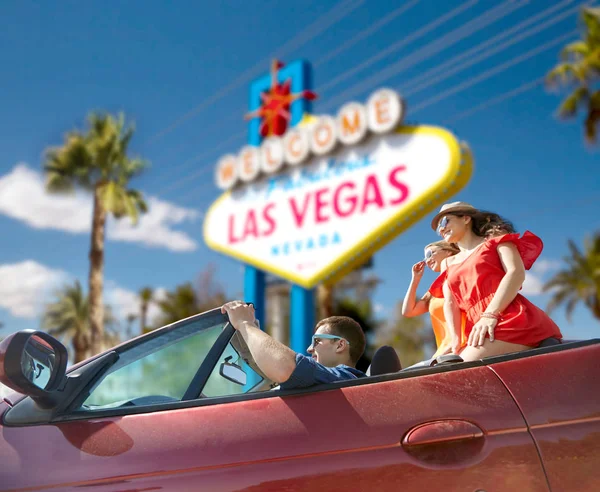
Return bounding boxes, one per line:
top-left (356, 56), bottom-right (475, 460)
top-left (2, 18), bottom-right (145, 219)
top-left (244, 60), bottom-right (317, 137)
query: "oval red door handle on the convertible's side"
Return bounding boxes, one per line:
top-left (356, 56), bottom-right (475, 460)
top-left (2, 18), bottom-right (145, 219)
top-left (402, 419), bottom-right (485, 465)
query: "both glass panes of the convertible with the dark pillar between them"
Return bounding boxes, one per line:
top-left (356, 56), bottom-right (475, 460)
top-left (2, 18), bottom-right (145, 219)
top-left (81, 311), bottom-right (270, 411)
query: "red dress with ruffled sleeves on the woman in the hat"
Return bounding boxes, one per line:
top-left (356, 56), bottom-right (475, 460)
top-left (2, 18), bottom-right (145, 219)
top-left (429, 231), bottom-right (562, 347)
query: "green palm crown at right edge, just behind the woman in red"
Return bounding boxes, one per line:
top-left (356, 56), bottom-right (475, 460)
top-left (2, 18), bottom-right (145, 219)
top-left (543, 232), bottom-right (600, 321)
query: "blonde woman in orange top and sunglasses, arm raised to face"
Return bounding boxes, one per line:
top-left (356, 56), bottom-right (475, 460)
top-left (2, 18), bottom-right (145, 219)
top-left (402, 241), bottom-right (466, 359)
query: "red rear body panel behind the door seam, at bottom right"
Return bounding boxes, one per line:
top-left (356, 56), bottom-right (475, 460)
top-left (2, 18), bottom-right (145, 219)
top-left (491, 345), bottom-right (600, 492)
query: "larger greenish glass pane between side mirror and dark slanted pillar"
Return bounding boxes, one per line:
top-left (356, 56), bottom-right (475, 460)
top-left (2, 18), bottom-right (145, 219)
top-left (81, 316), bottom-right (226, 410)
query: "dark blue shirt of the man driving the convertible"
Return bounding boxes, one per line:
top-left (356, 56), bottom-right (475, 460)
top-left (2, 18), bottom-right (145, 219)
top-left (279, 354), bottom-right (366, 389)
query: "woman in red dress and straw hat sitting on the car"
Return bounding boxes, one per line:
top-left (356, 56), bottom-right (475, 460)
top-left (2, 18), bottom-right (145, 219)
top-left (430, 202), bottom-right (562, 361)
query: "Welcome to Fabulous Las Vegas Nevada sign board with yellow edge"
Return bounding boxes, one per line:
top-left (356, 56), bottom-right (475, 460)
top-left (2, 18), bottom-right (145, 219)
top-left (204, 89), bottom-right (473, 288)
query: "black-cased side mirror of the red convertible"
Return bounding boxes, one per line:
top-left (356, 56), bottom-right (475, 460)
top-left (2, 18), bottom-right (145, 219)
top-left (0, 330), bottom-right (68, 408)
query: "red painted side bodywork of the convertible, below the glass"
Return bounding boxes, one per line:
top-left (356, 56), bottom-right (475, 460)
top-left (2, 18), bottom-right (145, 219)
top-left (0, 344), bottom-right (600, 492)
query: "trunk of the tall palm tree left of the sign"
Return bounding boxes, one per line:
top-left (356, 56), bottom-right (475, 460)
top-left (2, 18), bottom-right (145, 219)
top-left (89, 185), bottom-right (106, 355)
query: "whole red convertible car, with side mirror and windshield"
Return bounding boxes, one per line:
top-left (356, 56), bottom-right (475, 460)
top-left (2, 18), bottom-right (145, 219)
top-left (0, 310), bottom-right (600, 492)
